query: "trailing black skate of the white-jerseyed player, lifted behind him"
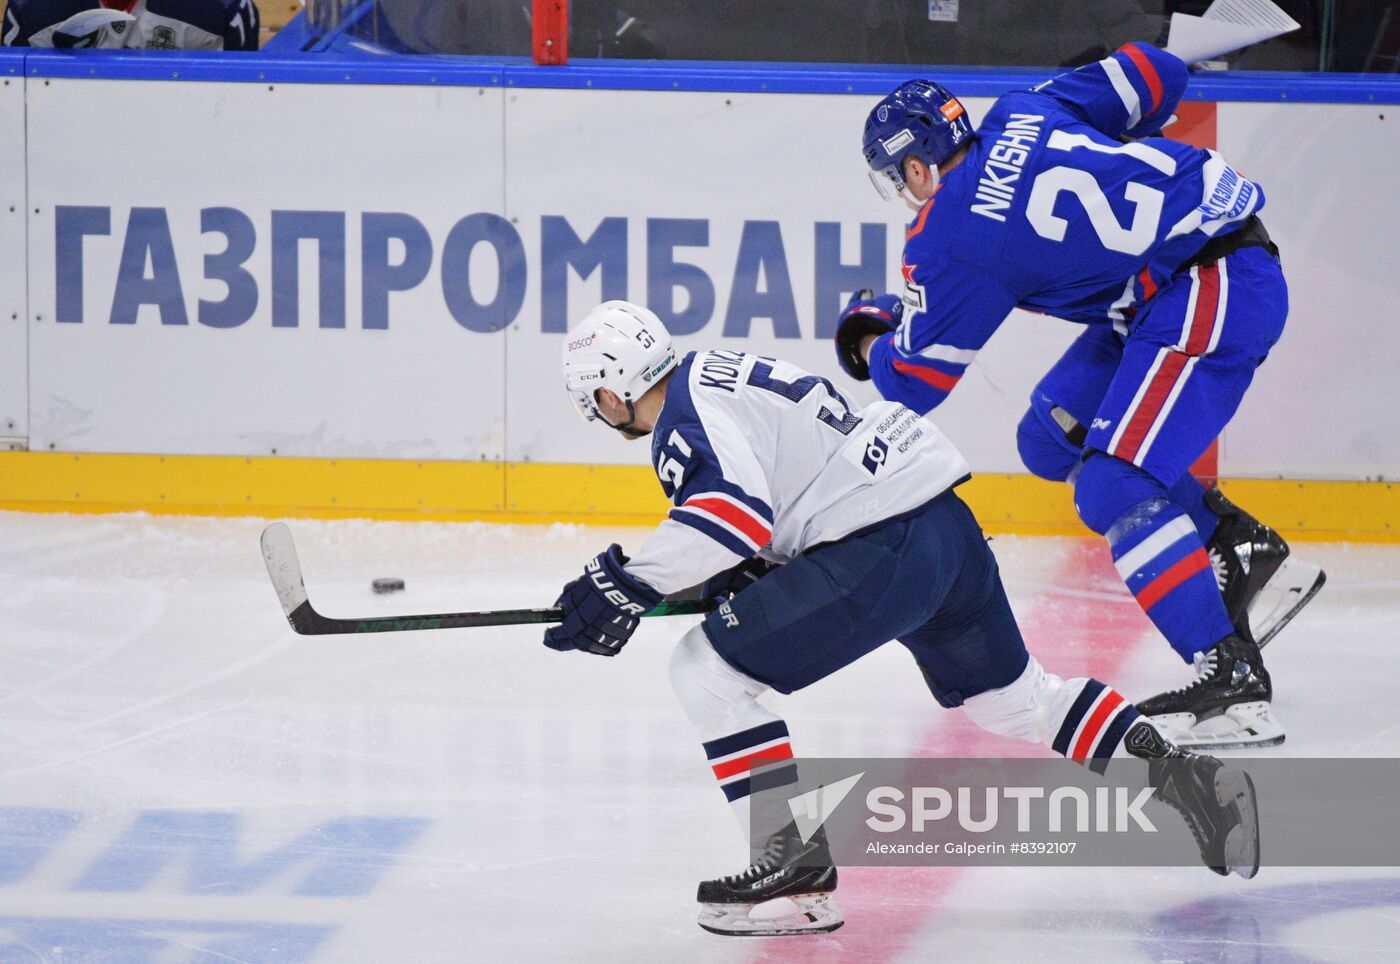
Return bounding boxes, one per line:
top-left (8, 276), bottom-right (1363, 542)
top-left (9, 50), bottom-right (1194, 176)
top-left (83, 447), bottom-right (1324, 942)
top-left (1123, 721), bottom-right (1259, 880)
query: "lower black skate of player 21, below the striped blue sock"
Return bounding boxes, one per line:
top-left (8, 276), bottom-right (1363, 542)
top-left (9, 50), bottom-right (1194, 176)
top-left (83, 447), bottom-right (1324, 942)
top-left (1137, 635), bottom-right (1284, 750)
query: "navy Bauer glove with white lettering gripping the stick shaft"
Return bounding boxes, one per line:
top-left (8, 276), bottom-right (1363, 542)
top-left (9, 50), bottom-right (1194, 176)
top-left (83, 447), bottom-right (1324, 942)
top-left (545, 543), bottom-right (661, 656)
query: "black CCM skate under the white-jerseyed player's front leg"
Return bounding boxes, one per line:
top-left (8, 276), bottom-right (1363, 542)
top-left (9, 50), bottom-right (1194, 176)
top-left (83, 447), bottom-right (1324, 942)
top-left (696, 823), bottom-right (846, 937)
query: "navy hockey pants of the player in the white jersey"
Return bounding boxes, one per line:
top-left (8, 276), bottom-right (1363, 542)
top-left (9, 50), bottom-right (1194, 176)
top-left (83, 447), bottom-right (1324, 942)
top-left (704, 491), bottom-right (1029, 707)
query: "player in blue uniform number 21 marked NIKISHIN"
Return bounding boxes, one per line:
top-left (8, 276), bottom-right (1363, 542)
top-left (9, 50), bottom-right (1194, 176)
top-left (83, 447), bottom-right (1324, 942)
top-left (836, 43), bottom-right (1323, 747)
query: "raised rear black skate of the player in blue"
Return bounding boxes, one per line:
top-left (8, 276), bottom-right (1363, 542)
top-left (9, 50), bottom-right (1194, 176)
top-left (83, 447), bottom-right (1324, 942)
top-left (1205, 488), bottom-right (1327, 646)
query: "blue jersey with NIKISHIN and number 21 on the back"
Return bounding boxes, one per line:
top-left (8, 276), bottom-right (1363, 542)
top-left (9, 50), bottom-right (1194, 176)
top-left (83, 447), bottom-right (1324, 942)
top-left (869, 43), bottom-right (1264, 411)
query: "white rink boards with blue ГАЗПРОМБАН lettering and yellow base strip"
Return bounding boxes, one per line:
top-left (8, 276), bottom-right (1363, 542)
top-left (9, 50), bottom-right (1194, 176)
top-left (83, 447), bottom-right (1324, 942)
top-left (0, 55), bottom-right (1400, 537)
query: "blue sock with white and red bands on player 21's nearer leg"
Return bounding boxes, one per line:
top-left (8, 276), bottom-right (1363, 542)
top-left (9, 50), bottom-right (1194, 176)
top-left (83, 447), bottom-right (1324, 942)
top-left (1074, 453), bottom-right (1235, 662)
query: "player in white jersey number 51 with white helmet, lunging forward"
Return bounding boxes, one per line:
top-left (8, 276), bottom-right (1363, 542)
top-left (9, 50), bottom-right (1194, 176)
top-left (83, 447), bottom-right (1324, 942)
top-left (545, 301), bottom-right (1259, 935)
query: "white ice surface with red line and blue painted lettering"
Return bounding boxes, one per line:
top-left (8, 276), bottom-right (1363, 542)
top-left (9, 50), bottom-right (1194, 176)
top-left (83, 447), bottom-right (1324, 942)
top-left (0, 513), bottom-right (1400, 964)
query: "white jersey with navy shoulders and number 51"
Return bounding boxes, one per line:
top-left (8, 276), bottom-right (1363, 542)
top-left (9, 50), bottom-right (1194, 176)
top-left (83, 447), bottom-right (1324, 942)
top-left (627, 351), bottom-right (969, 593)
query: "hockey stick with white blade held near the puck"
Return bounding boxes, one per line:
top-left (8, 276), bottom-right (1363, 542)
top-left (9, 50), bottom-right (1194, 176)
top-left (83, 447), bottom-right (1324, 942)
top-left (262, 522), bottom-right (714, 637)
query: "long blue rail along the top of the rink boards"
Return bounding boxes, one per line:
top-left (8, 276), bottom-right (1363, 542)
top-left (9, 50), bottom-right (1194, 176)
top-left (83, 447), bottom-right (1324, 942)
top-left (0, 34), bottom-right (1400, 104)
